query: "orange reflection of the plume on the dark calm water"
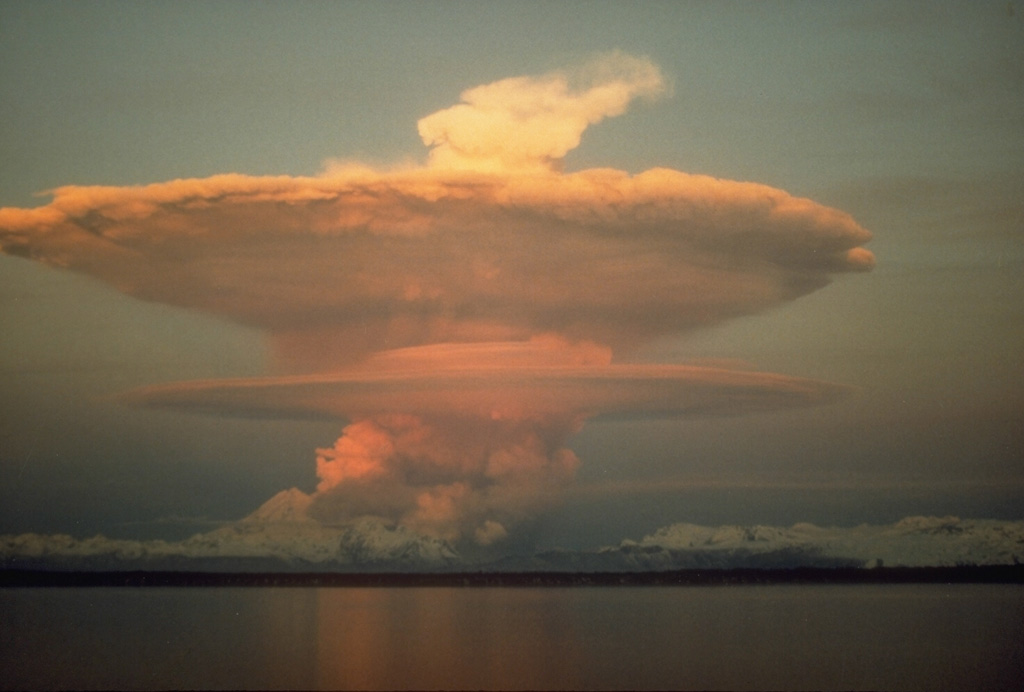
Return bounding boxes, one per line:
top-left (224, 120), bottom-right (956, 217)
top-left (316, 589), bottom-right (585, 689)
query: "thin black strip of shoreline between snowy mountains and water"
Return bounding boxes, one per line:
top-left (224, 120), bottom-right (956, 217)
top-left (0, 565), bottom-right (1024, 588)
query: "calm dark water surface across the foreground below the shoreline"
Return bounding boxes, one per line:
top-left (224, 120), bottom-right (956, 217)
top-left (0, 585), bottom-right (1024, 690)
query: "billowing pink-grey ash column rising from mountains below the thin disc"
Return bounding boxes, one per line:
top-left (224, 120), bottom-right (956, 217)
top-left (306, 414), bottom-right (580, 545)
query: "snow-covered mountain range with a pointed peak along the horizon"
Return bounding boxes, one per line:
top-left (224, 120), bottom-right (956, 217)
top-left (0, 507), bottom-right (1024, 572)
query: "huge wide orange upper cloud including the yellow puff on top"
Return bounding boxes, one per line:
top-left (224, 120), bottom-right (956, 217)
top-left (0, 53), bottom-right (873, 370)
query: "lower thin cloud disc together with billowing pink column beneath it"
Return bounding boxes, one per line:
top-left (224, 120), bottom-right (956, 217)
top-left (119, 337), bottom-right (846, 545)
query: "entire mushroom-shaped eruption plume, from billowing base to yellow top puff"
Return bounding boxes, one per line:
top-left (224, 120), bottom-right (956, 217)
top-left (0, 53), bottom-right (873, 544)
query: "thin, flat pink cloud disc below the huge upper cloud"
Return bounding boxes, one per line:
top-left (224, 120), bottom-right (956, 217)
top-left (125, 341), bottom-right (848, 422)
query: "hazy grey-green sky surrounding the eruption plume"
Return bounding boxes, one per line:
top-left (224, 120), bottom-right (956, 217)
top-left (0, 1), bottom-right (1024, 544)
